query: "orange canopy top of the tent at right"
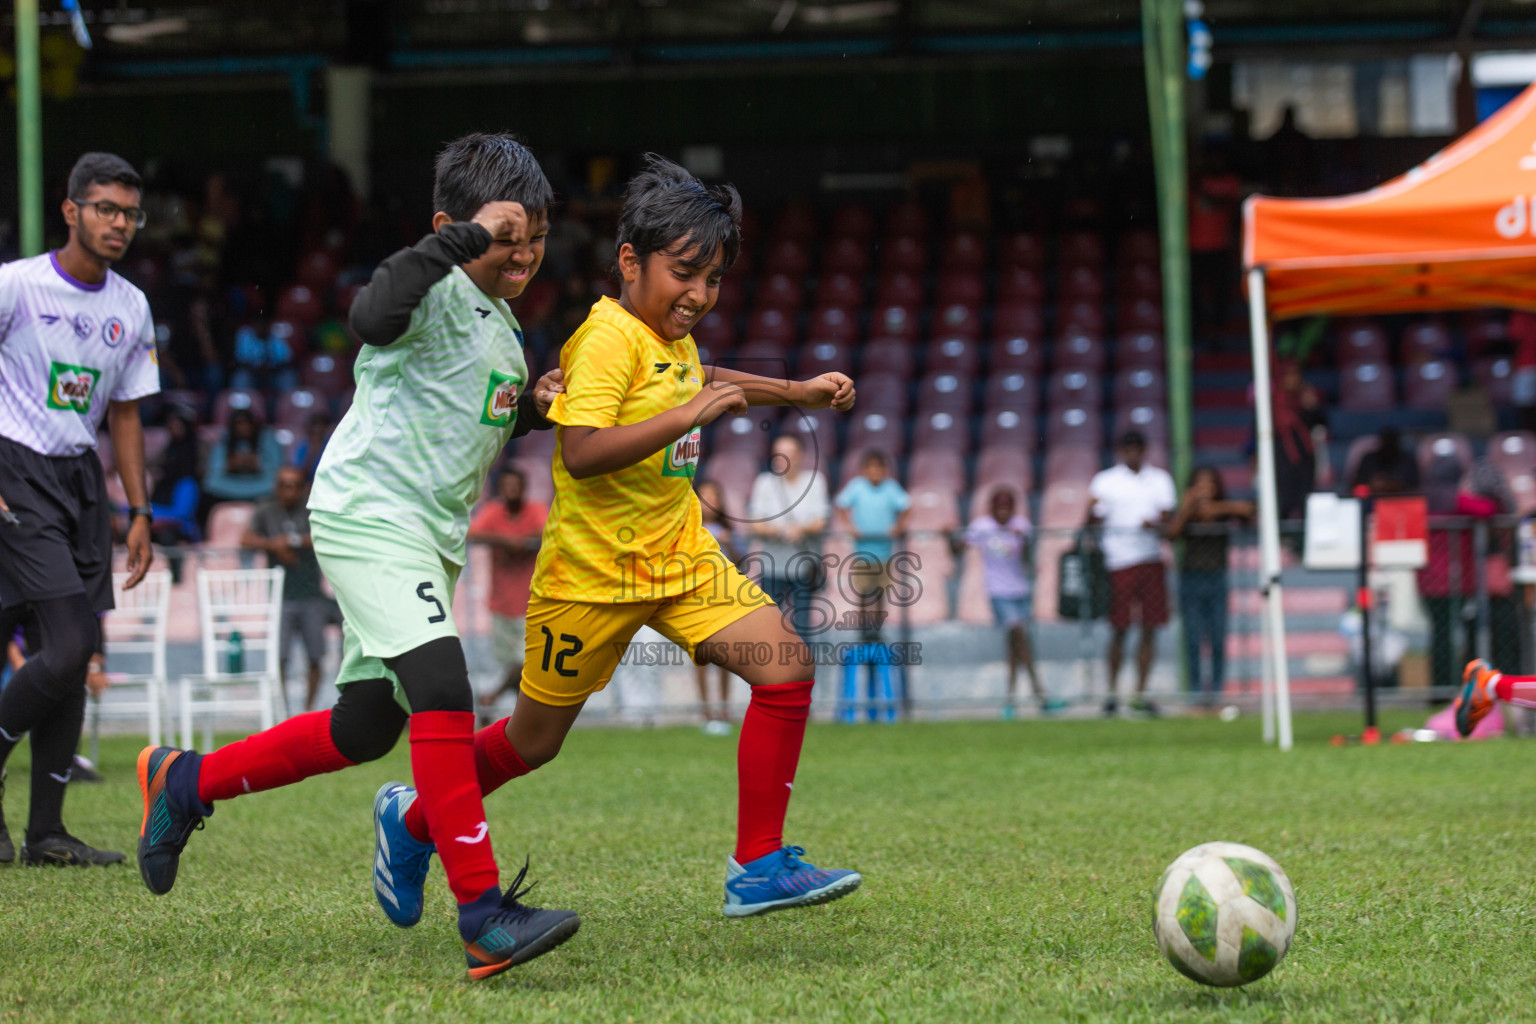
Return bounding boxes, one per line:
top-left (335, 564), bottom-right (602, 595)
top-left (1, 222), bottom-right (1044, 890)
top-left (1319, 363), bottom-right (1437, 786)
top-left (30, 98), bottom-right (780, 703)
top-left (1243, 86), bottom-right (1536, 319)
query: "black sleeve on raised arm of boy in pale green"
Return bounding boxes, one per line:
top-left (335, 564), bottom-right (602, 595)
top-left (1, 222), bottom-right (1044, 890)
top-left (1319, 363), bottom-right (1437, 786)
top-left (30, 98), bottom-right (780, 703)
top-left (347, 221), bottom-right (490, 345)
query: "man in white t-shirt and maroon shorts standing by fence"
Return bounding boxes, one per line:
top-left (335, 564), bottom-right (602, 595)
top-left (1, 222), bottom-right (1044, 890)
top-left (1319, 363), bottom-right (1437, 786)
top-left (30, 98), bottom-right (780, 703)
top-left (1087, 430), bottom-right (1178, 715)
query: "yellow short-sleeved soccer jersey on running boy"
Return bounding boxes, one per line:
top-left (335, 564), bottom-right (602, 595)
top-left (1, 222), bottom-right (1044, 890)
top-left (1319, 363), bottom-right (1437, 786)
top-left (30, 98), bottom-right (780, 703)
top-left (531, 296), bottom-right (720, 603)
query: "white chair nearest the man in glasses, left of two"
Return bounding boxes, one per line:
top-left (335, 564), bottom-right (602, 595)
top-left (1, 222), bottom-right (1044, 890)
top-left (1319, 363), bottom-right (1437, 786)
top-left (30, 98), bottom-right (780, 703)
top-left (91, 573), bottom-right (170, 760)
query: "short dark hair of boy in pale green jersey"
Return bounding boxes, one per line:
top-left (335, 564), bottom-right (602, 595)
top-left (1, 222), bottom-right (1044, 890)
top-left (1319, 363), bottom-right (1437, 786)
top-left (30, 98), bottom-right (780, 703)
top-left (432, 132), bottom-right (554, 221)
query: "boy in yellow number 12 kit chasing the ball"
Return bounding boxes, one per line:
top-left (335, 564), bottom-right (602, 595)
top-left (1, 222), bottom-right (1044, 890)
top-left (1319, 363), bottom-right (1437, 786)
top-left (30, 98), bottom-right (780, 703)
top-left (376, 155), bottom-right (860, 917)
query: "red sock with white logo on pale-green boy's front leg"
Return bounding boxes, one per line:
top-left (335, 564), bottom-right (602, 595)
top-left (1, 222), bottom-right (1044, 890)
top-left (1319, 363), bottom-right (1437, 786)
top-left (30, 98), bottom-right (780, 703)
top-left (410, 711), bottom-right (501, 903)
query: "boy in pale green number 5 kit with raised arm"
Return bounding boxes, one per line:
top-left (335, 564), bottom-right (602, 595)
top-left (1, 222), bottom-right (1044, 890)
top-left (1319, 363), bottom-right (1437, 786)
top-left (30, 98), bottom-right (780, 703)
top-left (138, 134), bottom-right (579, 978)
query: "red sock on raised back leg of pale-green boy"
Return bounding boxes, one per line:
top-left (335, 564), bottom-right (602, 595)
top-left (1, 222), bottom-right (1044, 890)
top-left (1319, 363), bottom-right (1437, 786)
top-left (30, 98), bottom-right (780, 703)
top-left (197, 711), bottom-right (352, 803)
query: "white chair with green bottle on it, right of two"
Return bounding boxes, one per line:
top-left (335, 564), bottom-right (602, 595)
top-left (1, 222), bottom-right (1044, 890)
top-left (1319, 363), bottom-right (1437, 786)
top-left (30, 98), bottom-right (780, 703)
top-left (181, 568), bottom-right (283, 751)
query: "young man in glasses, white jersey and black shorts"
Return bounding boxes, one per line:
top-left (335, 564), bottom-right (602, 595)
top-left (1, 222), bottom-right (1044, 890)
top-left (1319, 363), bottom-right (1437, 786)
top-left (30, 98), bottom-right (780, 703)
top-left (0, 154), bottom-right (160, 864)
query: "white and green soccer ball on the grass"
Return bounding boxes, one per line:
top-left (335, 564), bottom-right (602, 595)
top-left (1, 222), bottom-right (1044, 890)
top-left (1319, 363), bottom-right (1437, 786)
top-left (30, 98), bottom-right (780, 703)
top-left (1152, 843), bottom-right (1296, 987)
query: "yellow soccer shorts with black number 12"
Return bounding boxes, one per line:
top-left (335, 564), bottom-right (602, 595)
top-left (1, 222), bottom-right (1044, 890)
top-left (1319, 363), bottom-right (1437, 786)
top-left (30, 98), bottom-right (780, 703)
top-left (522, 563), bottom-right (773, 706)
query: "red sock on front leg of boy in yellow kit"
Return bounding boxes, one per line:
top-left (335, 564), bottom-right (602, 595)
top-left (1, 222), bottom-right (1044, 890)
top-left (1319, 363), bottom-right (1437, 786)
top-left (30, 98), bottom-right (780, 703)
top-left (736, 680), bottom-right (816, 864)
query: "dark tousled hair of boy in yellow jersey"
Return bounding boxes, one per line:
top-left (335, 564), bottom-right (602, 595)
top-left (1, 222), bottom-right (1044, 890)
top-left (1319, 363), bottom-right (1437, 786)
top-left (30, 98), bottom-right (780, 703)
top-left (613, 154), bottom-right (742, 273)
